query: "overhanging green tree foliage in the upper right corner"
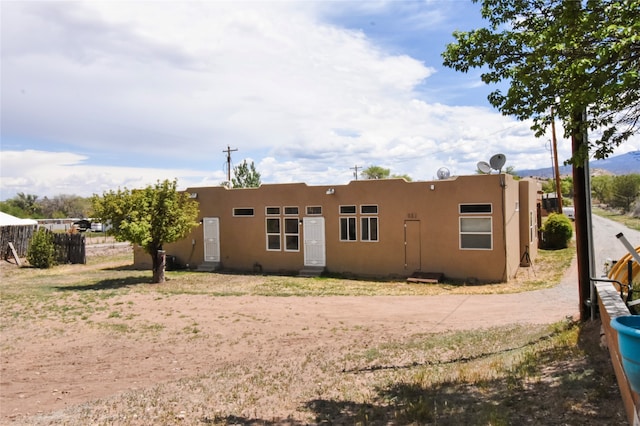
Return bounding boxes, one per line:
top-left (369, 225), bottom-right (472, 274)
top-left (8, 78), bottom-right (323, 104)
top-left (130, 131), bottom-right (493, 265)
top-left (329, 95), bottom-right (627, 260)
top-left (442, 0), bottom-right (640, 164)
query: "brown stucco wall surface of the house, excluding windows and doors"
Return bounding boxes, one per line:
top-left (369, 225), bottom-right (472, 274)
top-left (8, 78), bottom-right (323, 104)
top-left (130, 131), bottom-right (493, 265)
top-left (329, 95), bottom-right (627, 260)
top-left (135, 175), bottom-right (535, 282)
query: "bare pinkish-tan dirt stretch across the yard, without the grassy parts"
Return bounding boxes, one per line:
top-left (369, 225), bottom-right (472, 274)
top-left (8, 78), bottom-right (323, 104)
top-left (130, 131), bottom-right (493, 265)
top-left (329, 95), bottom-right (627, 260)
top-left (0, 243), bottom-right (624, 424)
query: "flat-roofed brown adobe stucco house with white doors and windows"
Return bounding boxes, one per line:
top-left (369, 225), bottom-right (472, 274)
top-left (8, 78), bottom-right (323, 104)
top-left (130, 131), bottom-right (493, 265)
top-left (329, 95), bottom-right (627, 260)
top-left (135, 174), bottom-right (538, 282)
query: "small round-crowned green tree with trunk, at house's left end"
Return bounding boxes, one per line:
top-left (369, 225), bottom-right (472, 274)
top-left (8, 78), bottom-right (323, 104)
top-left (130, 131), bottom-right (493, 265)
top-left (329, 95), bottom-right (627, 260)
top-left (92, 180), bottom-right (199, 283)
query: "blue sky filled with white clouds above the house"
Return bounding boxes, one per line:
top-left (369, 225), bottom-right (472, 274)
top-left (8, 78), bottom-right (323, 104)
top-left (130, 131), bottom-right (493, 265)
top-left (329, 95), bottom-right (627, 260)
top-left (0, 0), bottom-right (640, 199)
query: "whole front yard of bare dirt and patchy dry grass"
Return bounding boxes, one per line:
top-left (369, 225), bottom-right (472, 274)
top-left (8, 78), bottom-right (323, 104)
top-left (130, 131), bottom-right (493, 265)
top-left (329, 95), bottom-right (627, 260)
top-left (0, 244), bottom-right (627, 425)
